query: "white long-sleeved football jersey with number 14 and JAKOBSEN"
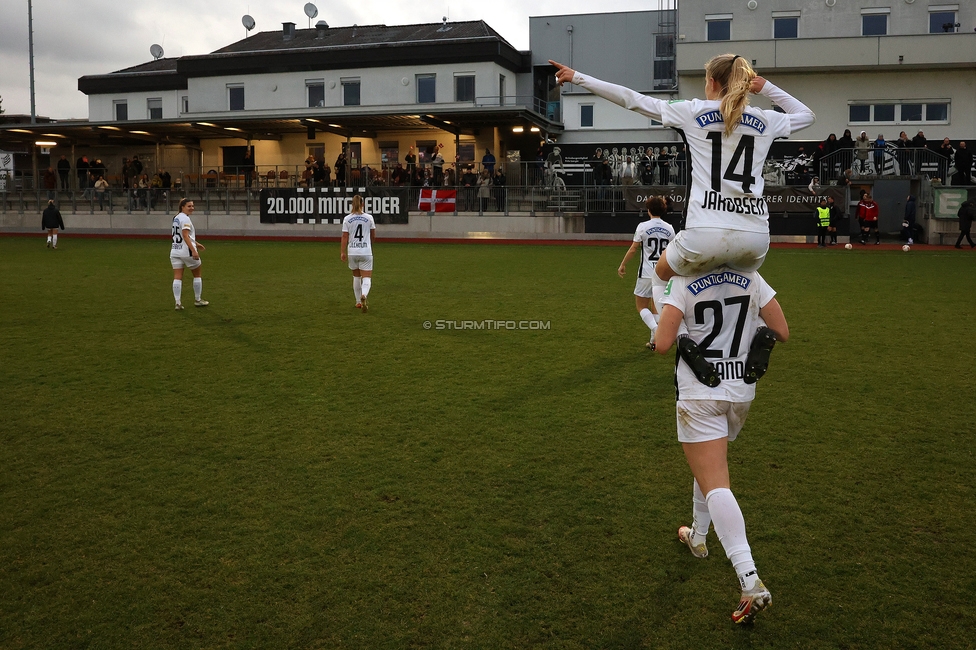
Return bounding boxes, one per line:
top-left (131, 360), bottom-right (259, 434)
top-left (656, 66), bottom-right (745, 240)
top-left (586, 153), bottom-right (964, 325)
top-left (573, 72), bottom-right (817, 233)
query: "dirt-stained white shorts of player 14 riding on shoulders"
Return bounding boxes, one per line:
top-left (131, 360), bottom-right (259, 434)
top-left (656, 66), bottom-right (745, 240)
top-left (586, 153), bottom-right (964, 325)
top-left (665, 228), bottom-right (769, 276)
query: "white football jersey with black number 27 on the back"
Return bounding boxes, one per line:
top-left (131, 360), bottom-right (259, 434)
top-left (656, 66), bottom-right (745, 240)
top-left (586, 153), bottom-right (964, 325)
top-left (662, 267), bottom-right (776, 402)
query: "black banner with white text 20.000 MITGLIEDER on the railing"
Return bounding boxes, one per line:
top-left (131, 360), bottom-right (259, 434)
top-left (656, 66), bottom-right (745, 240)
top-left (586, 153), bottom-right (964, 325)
top-left (261, 187), bottom-right (409, 224)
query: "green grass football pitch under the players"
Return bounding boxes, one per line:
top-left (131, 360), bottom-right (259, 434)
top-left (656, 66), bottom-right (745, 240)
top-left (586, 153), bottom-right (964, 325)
top-left (0, 233), bottom-right (976, 650)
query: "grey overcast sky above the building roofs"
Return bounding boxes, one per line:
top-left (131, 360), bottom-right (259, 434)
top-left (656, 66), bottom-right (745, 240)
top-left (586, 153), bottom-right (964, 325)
top-left (0, 0), bottom-right (662, 119)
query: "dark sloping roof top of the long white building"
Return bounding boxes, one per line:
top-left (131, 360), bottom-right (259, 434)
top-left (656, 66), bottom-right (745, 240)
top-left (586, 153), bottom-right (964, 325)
top-left (210, 20), bottom-right (512, 56)
